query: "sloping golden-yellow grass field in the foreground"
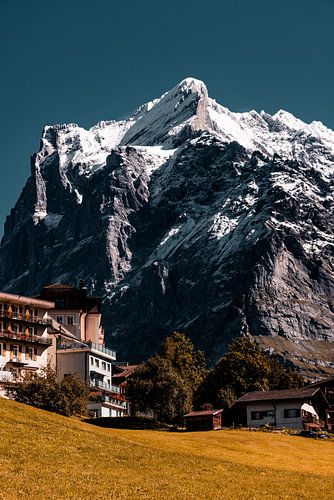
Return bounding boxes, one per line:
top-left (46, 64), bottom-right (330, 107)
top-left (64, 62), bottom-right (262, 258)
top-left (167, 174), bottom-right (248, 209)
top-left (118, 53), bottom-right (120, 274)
top-left (0, 398), bottom-right (334, 500)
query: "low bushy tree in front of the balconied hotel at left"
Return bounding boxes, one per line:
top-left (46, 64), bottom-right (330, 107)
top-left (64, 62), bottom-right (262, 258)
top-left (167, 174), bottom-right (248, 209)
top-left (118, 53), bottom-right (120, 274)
top-left (6, 366), bottom-right (89, 416)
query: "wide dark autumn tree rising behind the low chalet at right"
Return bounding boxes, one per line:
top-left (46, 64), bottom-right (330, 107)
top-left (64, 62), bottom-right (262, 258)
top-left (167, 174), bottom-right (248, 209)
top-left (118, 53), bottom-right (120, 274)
top-left (195, 337), bottom-right (303, 408)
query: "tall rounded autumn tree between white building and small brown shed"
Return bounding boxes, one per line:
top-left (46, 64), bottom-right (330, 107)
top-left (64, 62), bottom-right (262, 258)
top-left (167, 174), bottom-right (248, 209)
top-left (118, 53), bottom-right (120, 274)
top-left (127, 332), bottom-right (206, 424)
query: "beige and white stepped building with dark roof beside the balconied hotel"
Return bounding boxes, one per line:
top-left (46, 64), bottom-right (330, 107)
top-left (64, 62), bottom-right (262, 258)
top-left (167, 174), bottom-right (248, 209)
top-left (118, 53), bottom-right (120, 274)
top-left (40, 283), bottom-right (127, 417)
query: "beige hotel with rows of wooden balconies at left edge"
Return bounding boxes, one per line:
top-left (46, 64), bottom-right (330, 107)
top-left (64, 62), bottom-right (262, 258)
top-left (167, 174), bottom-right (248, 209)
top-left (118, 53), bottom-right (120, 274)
top-left (0, 292), bottom-right (56, 388)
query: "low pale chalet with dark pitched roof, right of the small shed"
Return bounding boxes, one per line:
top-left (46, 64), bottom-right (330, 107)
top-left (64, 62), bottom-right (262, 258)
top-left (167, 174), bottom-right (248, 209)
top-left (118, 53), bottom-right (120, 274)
top-left (236, 385), bottom-right (328, 429)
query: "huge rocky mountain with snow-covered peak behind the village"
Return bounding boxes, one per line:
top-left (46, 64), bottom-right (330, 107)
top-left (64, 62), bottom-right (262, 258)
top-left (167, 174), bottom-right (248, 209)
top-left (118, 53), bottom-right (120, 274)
top-left (0, 78), bottom-right (334, 375)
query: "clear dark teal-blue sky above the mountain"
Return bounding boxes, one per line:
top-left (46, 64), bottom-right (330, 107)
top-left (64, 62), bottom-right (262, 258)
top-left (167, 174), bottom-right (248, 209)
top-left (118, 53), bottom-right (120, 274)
top-left (0, 0), bottom-right (334, 233)
